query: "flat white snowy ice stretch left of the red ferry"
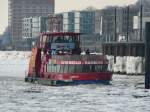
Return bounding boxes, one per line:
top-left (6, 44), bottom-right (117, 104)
top-left (0, 51), bottom-right (31, 77)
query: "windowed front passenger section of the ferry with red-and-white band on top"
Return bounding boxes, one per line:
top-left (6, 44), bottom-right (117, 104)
top-left (46, 55), bottom-right (108, 73)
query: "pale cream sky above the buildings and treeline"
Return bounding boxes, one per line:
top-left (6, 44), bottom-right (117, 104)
top-left (0, 0), bottom-right (137, 34)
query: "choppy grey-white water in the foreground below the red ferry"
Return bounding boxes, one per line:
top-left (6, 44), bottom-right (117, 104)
top-left (0, 75), bottom-right (150, 112)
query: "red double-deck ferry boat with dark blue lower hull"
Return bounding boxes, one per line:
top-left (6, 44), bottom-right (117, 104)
top-left (25, 32), bottom-right (112, 86)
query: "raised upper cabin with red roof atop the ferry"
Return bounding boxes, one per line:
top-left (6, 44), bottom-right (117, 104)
top-left (39, 32), bottom-right (81, 55)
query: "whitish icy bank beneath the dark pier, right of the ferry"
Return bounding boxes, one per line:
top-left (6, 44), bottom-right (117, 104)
top-left (107, 56), bottom-right (145, 74)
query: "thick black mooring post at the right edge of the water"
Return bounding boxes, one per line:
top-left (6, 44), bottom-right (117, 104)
top-left (145, 22), bottom-right (150, 89)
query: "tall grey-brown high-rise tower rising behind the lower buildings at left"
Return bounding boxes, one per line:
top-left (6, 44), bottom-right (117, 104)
top-left (8, 0), bottom-right (55, 49)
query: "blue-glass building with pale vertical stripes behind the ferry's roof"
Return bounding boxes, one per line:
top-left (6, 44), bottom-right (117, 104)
top-left (62, 10), bottom-right (95, 50)
